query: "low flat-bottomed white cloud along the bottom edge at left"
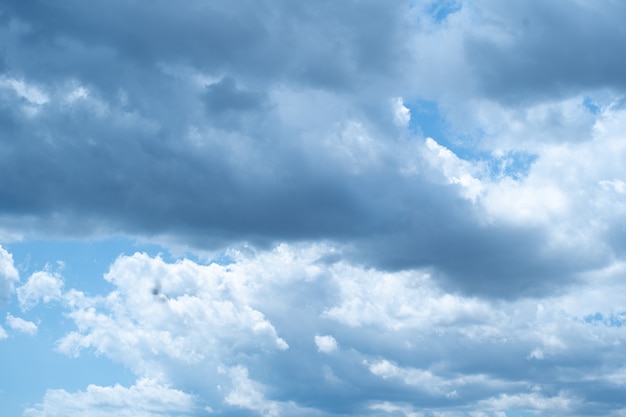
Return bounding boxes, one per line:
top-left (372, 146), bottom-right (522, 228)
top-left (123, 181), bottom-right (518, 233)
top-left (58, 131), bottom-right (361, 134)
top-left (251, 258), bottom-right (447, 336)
top-left (24, 378), bottom-right (197, 417)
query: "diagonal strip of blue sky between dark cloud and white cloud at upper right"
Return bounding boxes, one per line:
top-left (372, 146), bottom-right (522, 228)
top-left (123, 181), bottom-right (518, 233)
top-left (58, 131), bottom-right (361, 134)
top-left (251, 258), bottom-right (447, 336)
top-left (405, 100), bottom-right (537, 179)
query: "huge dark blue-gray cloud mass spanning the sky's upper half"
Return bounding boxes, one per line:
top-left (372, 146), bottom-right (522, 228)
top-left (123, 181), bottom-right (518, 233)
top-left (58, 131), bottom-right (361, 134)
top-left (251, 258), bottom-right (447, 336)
top-left (0, 0), bottom-right (626, 297)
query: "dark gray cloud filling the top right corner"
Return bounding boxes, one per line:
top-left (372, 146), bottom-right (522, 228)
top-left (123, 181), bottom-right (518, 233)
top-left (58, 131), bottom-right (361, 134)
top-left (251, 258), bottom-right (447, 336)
top-left (465, 0), bottom-right (626, 104)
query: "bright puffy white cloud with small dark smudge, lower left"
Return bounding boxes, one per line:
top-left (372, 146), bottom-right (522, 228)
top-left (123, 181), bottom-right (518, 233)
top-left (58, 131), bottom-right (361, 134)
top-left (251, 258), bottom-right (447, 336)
top-left (59, 253), bottom-right (289, 375)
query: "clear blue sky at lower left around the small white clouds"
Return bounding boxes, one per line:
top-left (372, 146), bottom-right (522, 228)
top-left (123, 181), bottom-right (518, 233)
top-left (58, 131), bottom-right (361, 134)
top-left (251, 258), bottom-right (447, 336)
top-left (0, 237), bottom-right (172, 417)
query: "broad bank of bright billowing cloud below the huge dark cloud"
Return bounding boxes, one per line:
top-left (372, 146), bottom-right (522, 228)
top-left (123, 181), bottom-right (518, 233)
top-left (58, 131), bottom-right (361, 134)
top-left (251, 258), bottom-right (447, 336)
top-left (17, 245), bottom-right (626, 416)
